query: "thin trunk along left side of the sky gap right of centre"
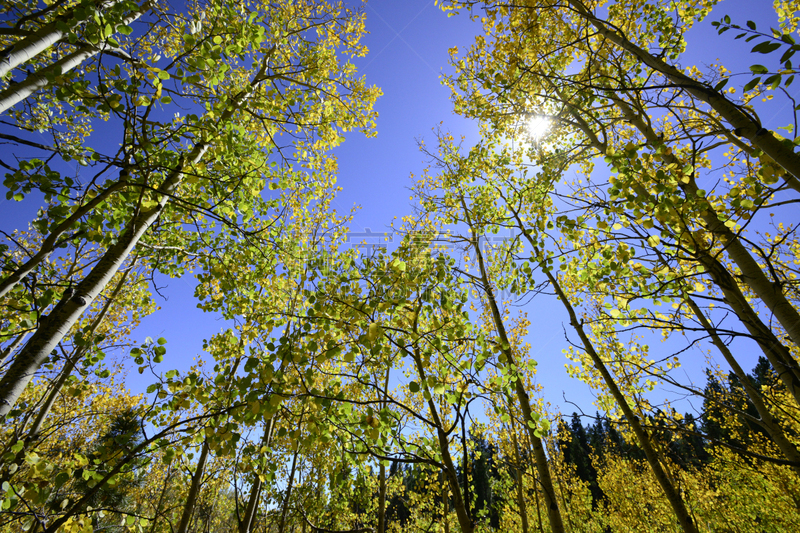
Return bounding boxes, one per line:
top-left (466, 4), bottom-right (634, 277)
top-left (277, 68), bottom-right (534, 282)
top-left (461, 214), bottom-right (566, 533)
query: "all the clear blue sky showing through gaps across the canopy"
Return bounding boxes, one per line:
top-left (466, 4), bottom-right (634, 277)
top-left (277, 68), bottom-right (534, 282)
top-left (0, 0), bottom-right (800, 413)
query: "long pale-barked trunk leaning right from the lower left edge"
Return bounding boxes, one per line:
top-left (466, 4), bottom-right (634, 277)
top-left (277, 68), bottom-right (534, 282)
top-left (0, 69), bottom-right (266, 417)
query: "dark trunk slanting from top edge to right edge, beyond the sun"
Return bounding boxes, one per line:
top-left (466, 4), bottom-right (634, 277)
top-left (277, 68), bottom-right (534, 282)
top-left (567, 0), bottom-right (800, 193)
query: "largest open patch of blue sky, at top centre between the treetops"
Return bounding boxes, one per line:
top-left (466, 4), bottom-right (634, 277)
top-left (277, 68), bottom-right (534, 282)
top-left (335, 0), bottom-right (480, 231)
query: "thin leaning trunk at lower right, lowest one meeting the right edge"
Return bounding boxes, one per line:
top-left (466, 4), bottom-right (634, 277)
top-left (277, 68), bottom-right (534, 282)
top-left (686, 296), bottom-right (800, 475)
